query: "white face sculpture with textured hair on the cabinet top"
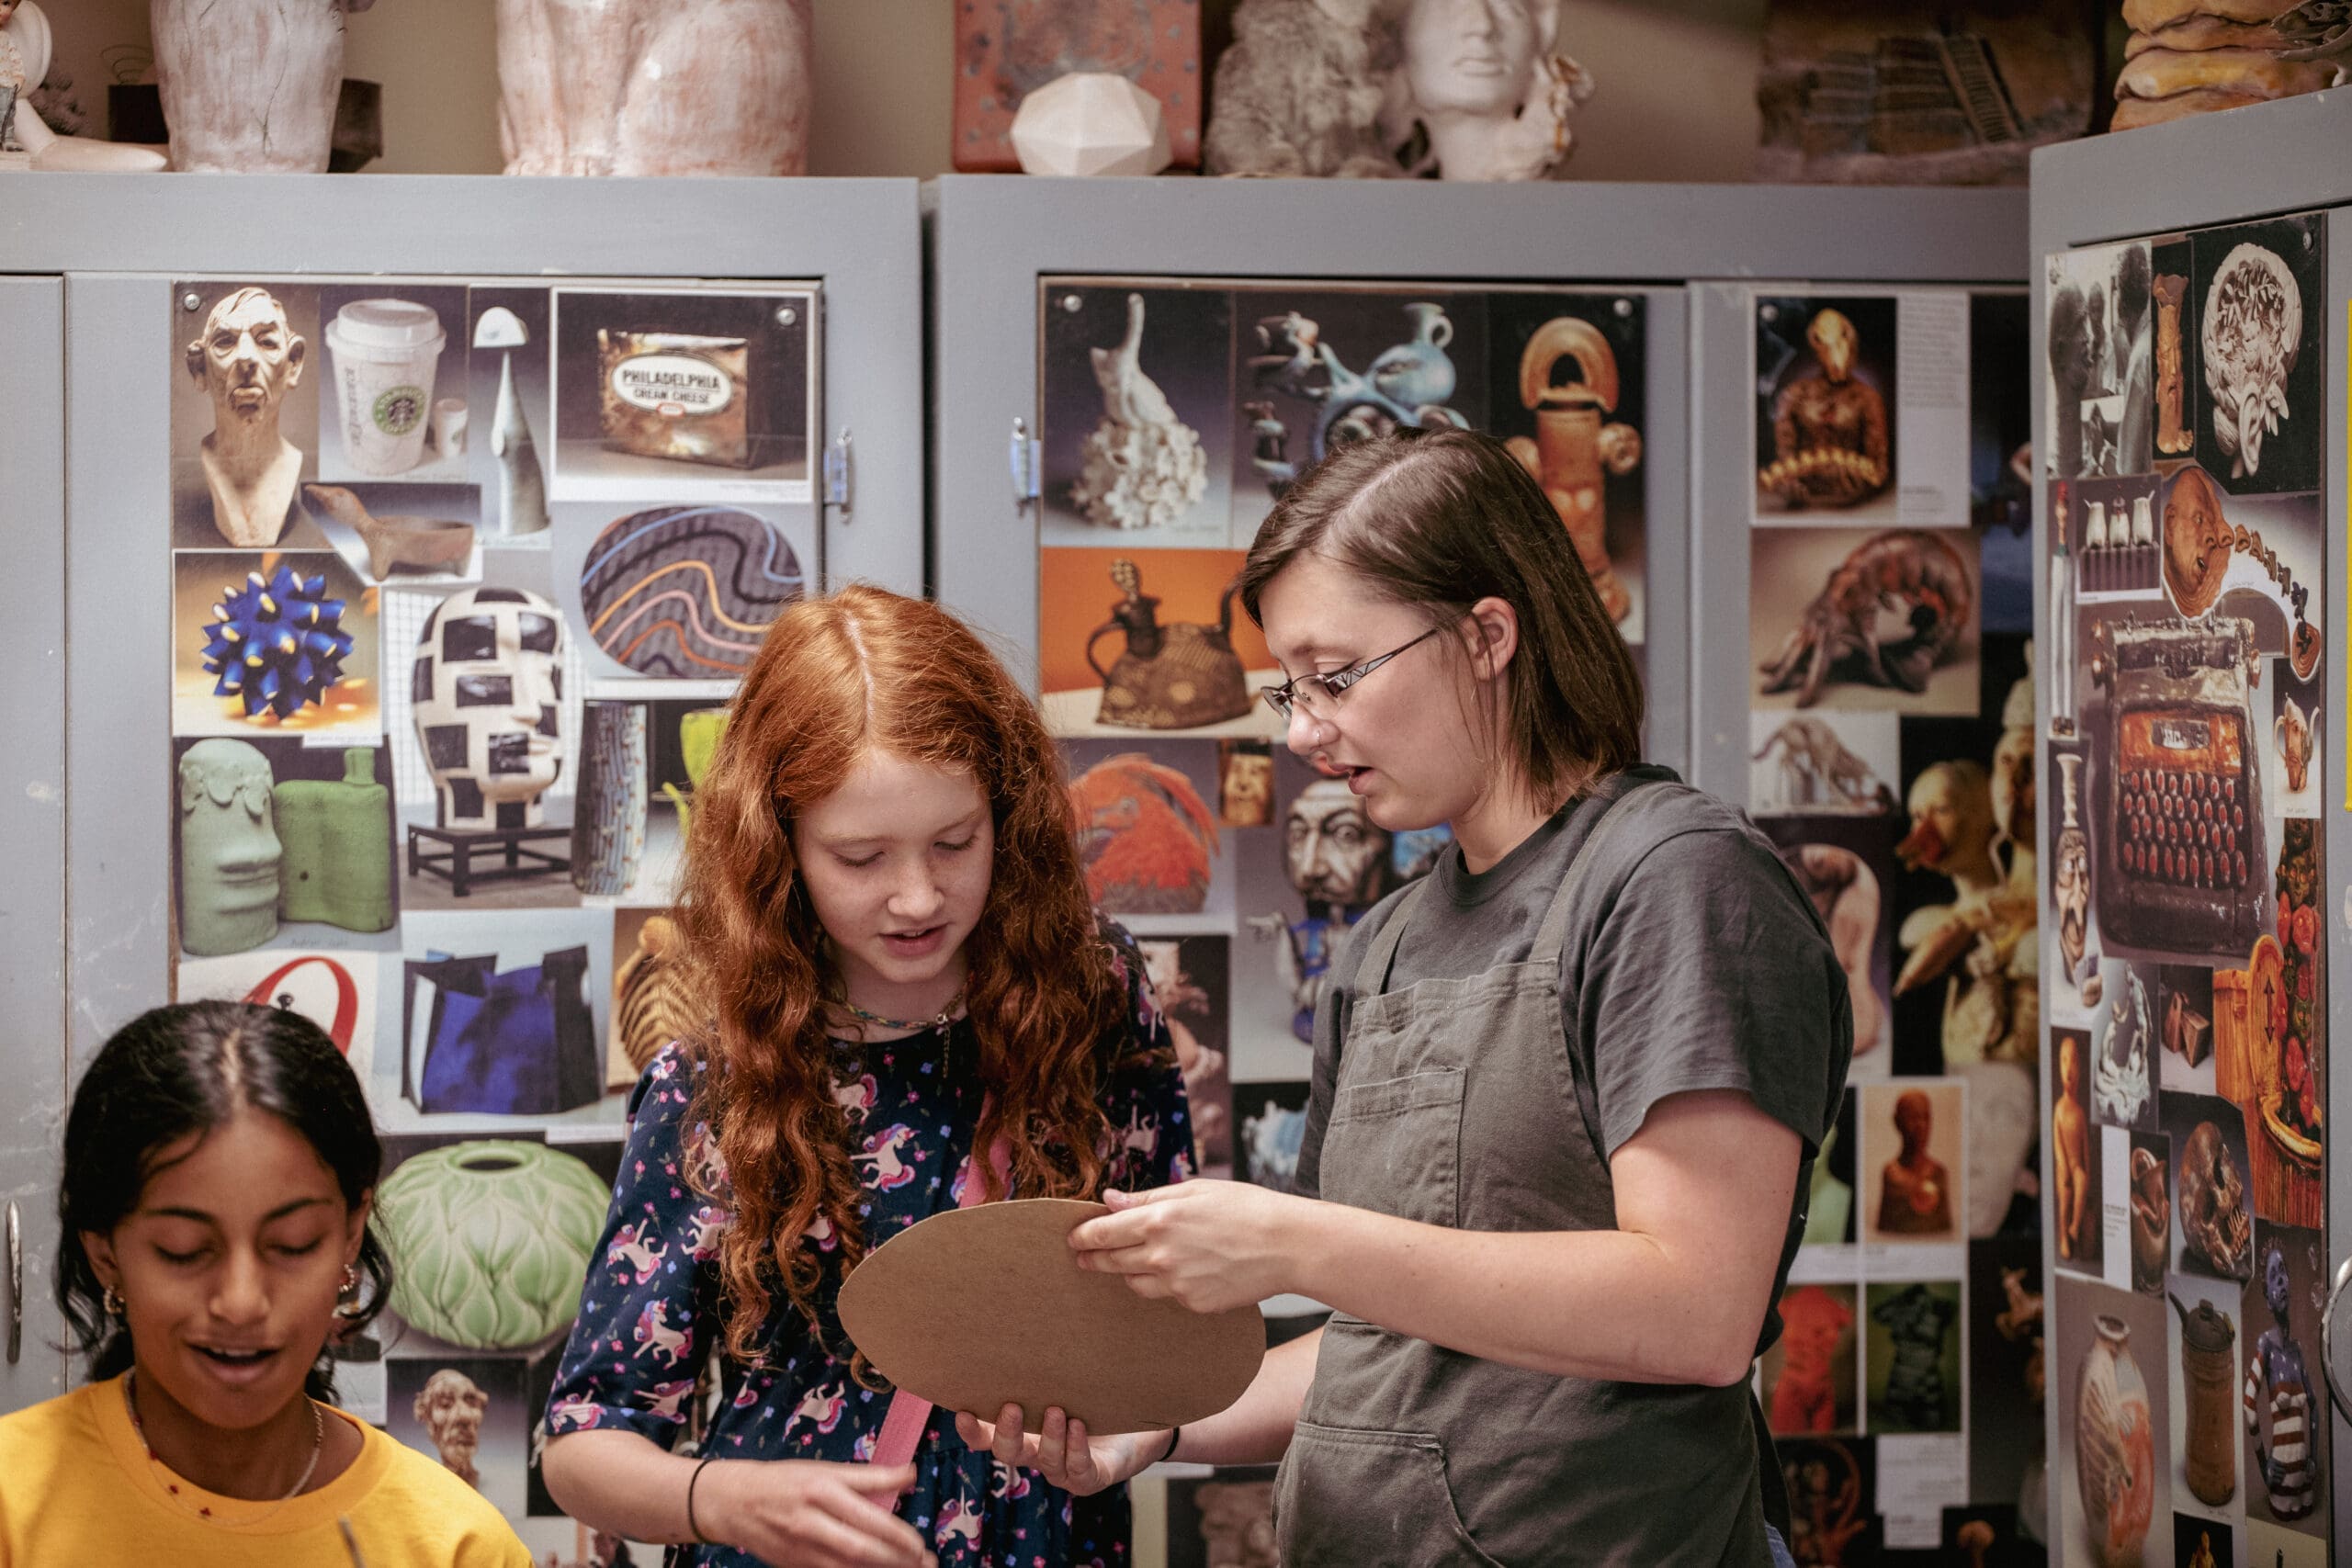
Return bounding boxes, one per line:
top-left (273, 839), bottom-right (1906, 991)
top-left (1381, 0), bottom-right (1592, 181)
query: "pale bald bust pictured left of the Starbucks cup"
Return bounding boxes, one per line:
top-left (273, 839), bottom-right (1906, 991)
top-left (186, 289), bottom-right (311, 550)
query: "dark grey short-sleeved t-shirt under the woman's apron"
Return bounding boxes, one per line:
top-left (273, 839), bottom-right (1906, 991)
top-left (1298, 764), bottom-right (1853, 1354)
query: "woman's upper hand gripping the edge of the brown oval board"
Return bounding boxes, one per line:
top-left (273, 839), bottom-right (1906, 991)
top-left (1070, 1180), bottom-right (1315, 1312)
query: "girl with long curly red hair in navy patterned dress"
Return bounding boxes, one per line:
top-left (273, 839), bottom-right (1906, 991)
top-left (543, 588), bottom-right (1193, 1568)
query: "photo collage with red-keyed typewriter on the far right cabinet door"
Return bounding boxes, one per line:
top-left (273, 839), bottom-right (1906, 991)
top-left (2044, 216), bottom-right (2334, 1568)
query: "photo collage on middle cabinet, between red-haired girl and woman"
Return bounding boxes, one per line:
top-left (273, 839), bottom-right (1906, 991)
top-left (1037, 277), bottom-right (1672, 1563)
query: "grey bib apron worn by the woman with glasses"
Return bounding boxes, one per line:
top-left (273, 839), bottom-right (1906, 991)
top-left (1275, 787), bottom-right (1771, 1568)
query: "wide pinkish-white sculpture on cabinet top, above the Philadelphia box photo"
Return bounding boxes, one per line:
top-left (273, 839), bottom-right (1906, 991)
top-left (499, 0), bottom-right (814, 174)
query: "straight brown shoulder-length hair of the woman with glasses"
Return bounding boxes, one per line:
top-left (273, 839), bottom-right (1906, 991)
top-left (1242, 428), bottom-right (1642, 808)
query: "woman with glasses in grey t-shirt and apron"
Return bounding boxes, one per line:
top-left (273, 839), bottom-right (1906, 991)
top-left (971, 430), bottom-right (1853, 1568)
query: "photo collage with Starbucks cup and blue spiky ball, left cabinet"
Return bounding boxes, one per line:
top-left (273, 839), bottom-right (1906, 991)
top-left (158, 266), bottom-right (823, 1551)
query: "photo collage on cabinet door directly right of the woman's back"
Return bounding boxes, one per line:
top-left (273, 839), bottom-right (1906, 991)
top-left (1747, 285), bottom-right (2041, 1565)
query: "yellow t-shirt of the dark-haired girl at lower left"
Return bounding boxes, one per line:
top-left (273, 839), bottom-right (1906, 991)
top-left (0, 1378), bottom-right (532, 1568)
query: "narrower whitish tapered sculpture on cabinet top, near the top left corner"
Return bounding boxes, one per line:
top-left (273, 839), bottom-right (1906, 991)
top-left (148, 0), bottom-right (374, 174)
